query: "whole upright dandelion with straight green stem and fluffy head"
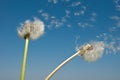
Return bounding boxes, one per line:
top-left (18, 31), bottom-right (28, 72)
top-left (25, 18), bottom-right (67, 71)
top-left (18, 18), bottom-right (44, 80)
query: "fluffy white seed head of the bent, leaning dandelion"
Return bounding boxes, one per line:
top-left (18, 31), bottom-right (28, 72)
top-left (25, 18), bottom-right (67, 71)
top-left (80, 42), bottom-right (104, 62)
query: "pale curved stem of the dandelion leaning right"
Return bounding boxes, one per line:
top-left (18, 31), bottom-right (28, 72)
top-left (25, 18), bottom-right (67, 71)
top-left (45, 51), bottom-right (80, 80)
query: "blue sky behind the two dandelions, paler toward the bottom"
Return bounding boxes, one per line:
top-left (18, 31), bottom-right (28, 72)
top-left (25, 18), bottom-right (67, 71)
top-left (0, 0), bottom-right (120, 80)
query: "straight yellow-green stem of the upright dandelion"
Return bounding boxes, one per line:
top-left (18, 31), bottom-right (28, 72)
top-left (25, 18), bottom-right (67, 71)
top-left (20, 38), bottom-right (29, 80)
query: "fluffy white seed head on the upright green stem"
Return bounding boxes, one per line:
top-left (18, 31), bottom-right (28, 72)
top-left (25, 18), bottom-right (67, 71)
top-left (18, 18), bottom-right (44, 40)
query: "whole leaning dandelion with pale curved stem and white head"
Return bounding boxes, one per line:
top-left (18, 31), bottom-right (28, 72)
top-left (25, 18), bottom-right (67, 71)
top-left (45, 42), bottom-right (104, 80)
